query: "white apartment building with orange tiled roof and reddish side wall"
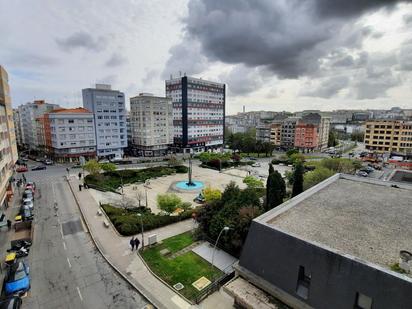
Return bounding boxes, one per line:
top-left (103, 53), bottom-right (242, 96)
top-left (41, 107), bottom-right (96, 161)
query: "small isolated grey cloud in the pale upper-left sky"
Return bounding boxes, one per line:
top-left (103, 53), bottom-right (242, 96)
top-left (55, 31), bottom-right (107, 52)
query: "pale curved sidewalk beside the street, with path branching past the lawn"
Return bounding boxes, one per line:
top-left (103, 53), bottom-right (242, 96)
top-left (69, 177), bottom-right (232, 309)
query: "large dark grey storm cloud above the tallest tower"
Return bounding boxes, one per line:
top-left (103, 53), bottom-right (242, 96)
top-left (166, 0), bottom-right (408, 78)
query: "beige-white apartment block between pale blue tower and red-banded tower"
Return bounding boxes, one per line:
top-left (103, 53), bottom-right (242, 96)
top-left (130, 93), bottom-right (173, 156)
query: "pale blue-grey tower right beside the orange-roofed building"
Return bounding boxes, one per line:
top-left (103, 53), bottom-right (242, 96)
top-left (82, 84), bottom-right (127, 158)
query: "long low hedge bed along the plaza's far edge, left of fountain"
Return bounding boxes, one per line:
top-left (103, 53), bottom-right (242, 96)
top-left (84, 165), bottom-right (188, 191)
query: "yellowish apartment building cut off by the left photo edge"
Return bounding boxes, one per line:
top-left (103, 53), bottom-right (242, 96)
top-left (0, 66), bottom-right (17, 208)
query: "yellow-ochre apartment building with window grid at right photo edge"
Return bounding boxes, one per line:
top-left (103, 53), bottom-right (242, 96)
top-left (364, 120), bottom-right (412, 154)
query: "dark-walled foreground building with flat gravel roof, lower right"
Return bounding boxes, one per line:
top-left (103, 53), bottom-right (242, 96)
top-left (235, 174), bottom-right (412, 309)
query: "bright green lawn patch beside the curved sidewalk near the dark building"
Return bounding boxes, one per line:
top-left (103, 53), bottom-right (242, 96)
top-left (142, 232), bottom-right (223, 299)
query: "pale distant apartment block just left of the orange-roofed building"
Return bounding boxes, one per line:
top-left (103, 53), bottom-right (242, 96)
top-left (18, 100), bottom-right (60, 150)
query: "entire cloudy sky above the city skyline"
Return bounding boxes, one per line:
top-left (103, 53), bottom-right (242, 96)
top-left (0, 0), bottom-right (412, 114)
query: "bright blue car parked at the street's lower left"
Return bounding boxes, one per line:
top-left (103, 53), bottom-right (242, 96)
top-left (4, 261), bottom-right (30, 295)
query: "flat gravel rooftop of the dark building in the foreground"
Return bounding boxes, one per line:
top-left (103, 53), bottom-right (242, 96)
top-left (266, 175), bottom-right (412, 268)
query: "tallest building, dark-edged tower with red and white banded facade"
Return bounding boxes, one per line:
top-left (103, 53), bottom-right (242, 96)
top-left (166, 76), bottom-right (226, 153)
